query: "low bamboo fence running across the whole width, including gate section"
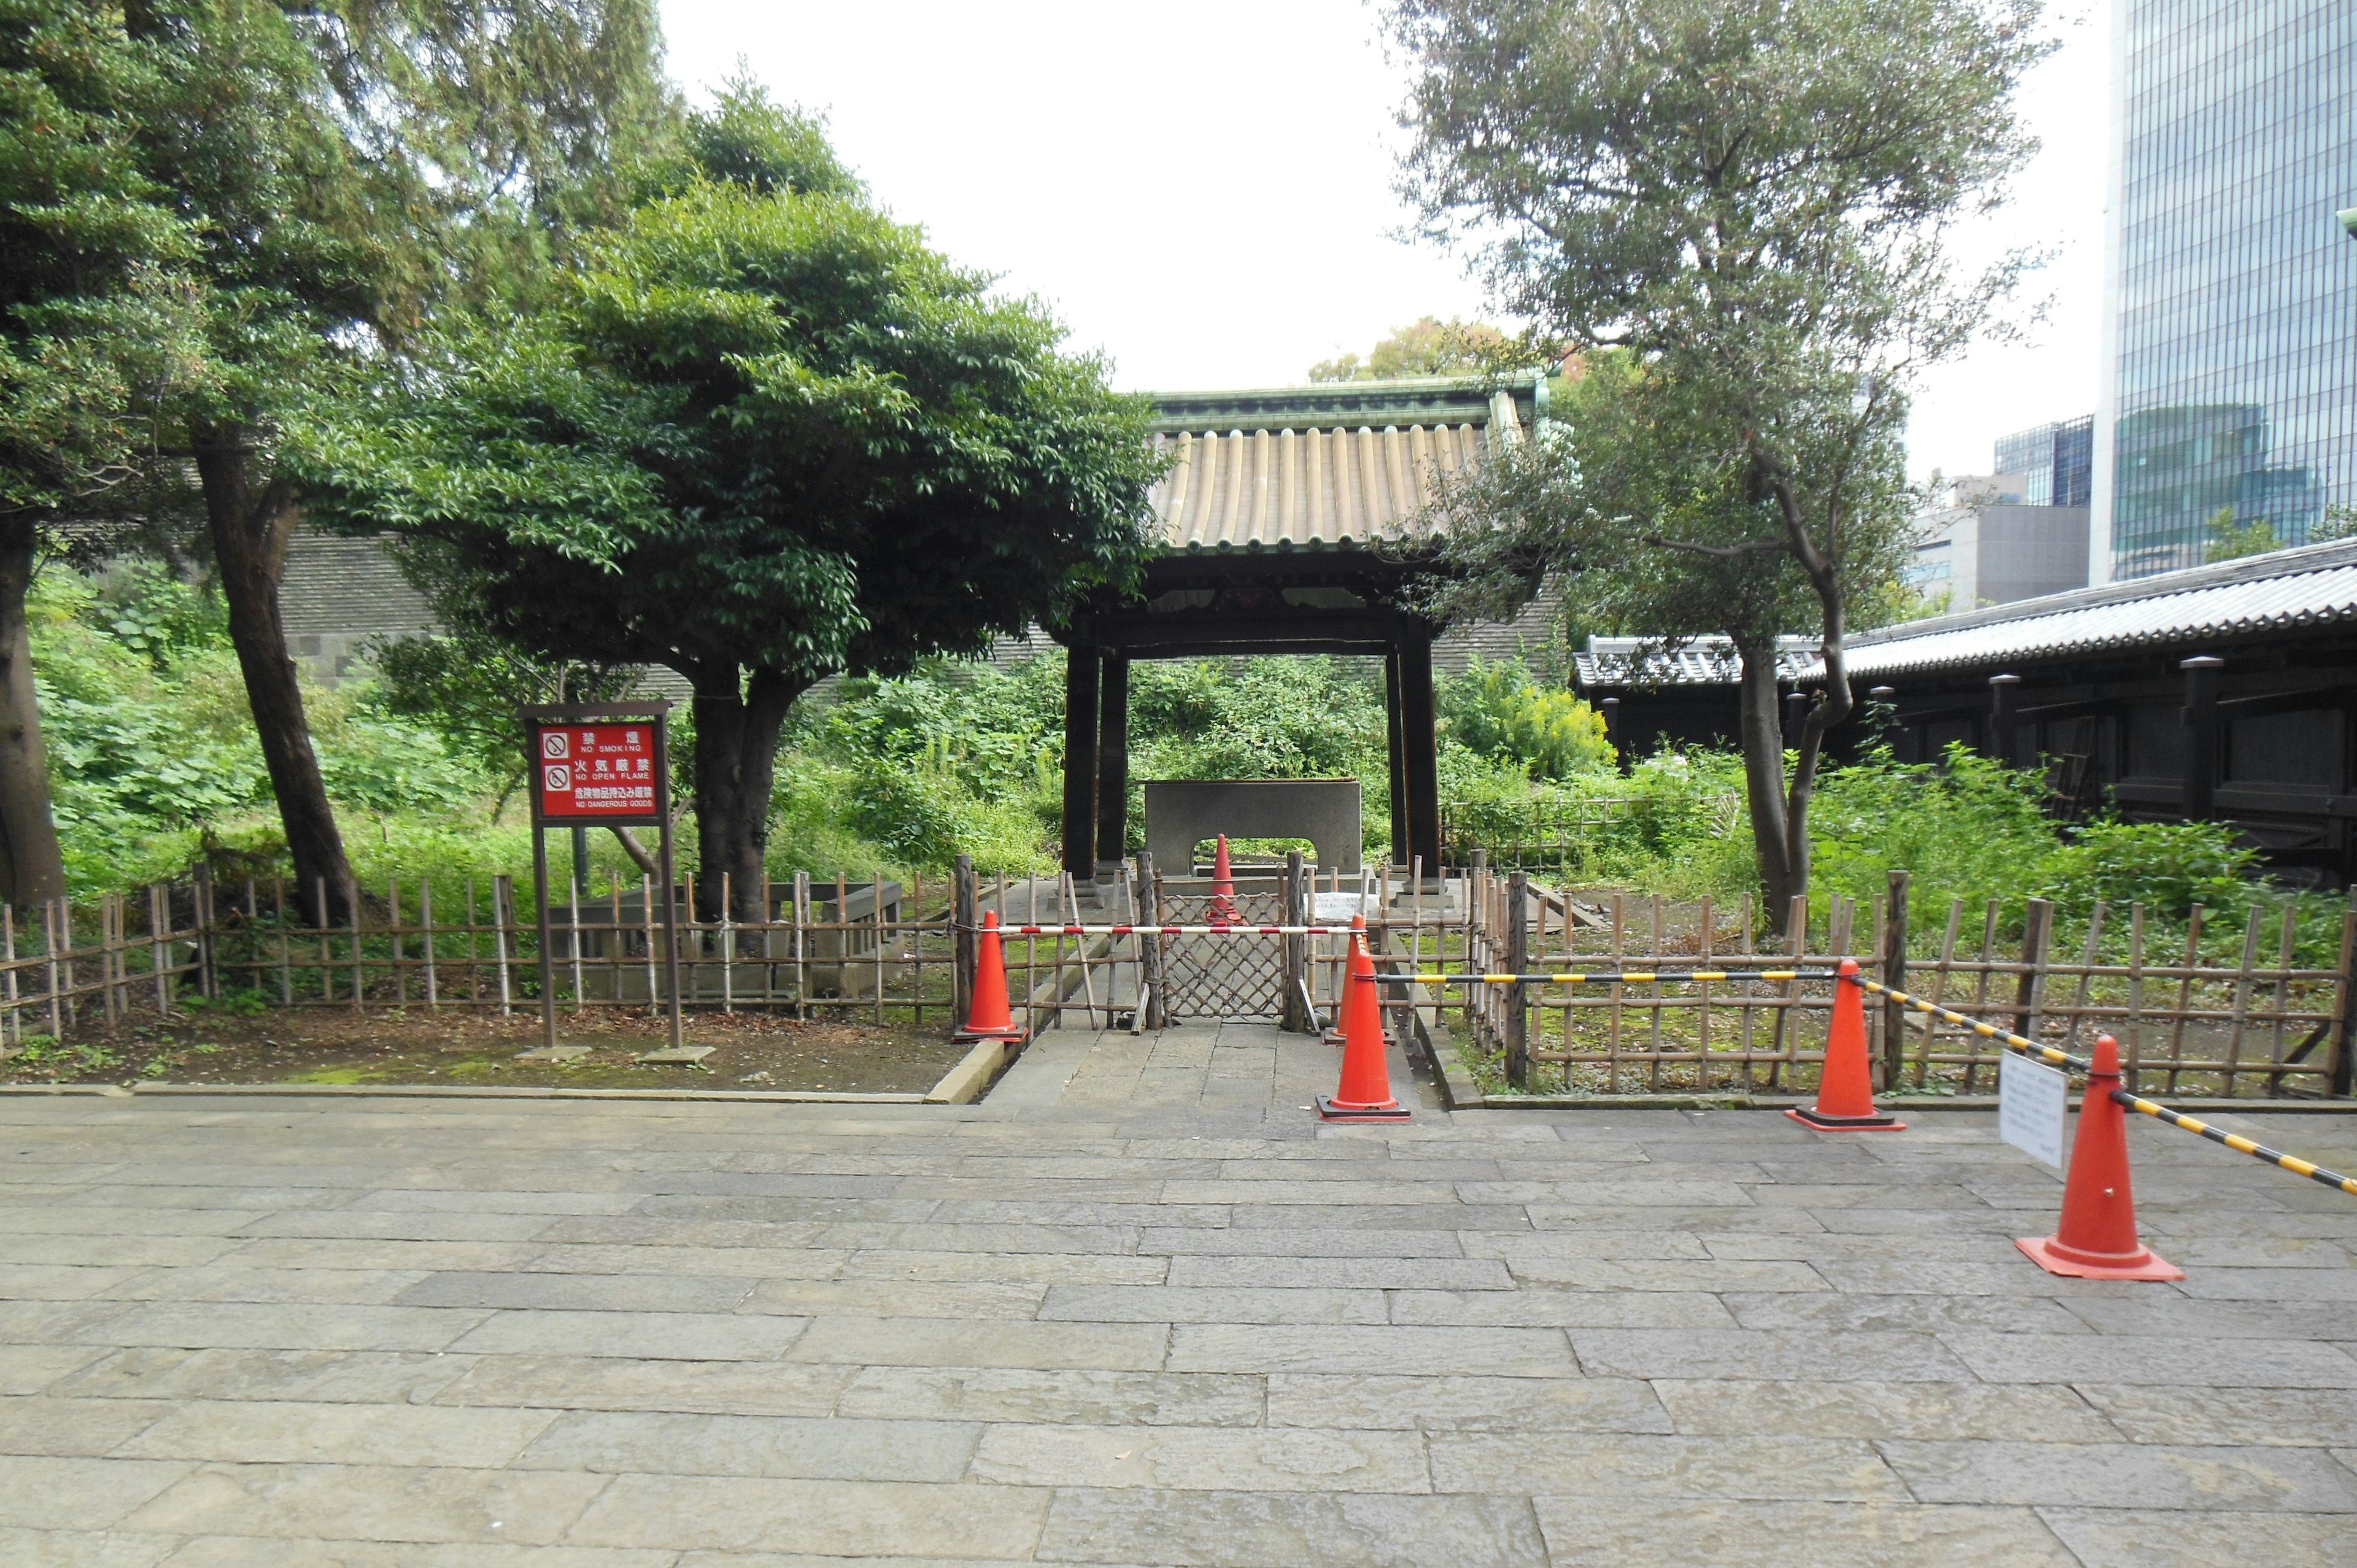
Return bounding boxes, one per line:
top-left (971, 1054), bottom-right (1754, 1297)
top-left (0, 854), bottom-right (2357, 1097)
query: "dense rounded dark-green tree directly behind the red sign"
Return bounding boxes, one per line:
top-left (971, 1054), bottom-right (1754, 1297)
top-left (302, 90), bottom-right (1155, 917)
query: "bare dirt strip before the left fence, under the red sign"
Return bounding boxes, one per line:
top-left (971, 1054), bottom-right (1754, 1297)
top-left (0, 1007), bottom-right (966, 1094)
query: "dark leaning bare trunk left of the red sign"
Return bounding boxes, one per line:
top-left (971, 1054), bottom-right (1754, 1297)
top-left (193, 425), bottom-right (354, 924)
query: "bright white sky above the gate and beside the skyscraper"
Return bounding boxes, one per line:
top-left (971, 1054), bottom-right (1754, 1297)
top-left (662, 0), bottom-right (2110, 474)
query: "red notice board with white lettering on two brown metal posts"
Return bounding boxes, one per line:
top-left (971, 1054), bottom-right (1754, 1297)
top-left (516, 703), bottom-right (686, 1052)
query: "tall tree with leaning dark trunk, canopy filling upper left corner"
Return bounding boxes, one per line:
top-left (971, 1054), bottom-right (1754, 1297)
top-left (0, 0), bottom-right (665, 917)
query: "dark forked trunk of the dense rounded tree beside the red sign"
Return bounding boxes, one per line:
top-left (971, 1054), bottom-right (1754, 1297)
top-left (681, 663), bottom-right (808, 919)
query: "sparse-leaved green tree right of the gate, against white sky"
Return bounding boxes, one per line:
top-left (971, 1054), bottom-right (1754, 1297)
top-left (1391, 0), bottom-right (2046, 915)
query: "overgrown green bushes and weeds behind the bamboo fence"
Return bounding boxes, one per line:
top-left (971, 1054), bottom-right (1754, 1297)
top-left (31, 549), bottom-right (2340, 967)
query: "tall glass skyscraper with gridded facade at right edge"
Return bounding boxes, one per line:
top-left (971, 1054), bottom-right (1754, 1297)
top-left (2091, 0), bottom-right (2357, 577)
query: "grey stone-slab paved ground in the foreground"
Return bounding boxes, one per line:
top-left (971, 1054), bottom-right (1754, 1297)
top-left (0, 1028), bottom-right (2357, 1568)
